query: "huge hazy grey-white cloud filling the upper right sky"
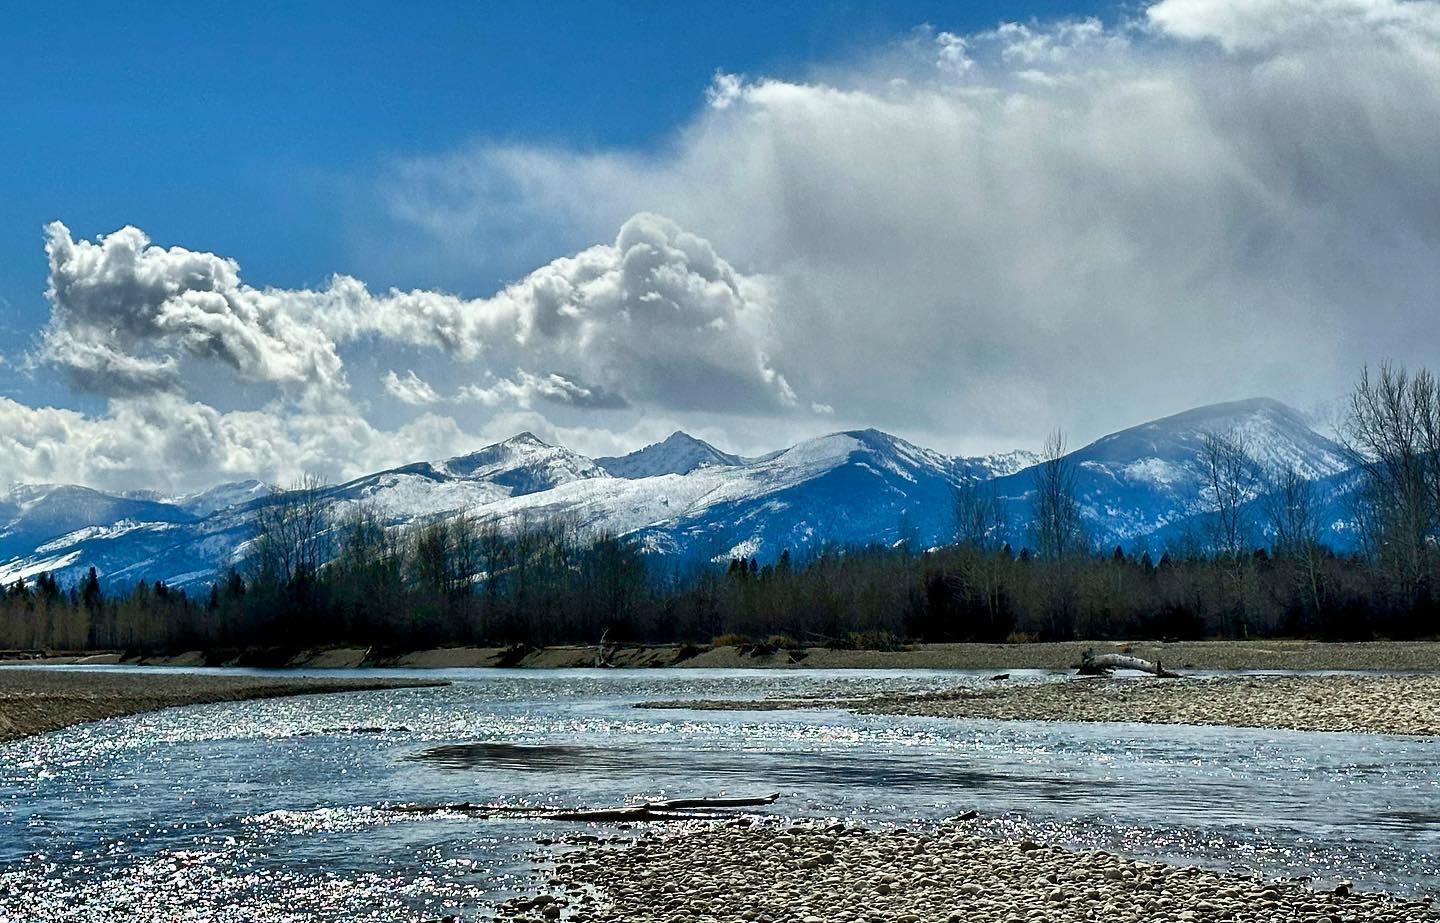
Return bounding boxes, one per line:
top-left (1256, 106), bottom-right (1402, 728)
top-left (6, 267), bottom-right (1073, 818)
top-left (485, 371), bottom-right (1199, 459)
top-left (386, 0), bottom-right (1440, 449)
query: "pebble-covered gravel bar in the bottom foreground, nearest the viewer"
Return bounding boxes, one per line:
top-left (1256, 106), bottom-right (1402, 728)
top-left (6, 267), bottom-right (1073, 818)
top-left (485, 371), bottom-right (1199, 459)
top-left (512, 821), bottom-right (1440, 923)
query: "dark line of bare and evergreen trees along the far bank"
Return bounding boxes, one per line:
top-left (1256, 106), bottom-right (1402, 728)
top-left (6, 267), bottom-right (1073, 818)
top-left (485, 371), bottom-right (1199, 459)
top-left (0, 357), bottom-right (1440, 652)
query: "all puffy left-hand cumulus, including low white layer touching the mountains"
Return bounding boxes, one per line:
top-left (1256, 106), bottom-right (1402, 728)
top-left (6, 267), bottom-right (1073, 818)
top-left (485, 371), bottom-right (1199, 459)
top-left (0, 213), bottom-right (799, 488)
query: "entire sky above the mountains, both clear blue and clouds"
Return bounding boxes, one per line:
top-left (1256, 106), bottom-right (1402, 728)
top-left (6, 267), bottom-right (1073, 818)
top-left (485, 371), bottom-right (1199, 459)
top-left (0, 0), bottom-right (1440, 491)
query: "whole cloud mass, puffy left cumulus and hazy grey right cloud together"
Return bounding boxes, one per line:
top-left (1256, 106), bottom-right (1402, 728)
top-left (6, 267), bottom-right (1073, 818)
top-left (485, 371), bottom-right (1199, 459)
top-left (11, 0), bottom-right (1440, 487)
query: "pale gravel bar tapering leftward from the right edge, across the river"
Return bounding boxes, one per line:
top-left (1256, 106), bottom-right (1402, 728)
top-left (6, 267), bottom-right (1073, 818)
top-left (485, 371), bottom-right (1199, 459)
top-left (641, 674), bottom-right (1440, 736)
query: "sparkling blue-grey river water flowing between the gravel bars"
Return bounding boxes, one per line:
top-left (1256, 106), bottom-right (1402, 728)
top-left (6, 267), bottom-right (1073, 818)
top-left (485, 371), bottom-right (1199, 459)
top-left (0, 670), bottom-right (1440, 923)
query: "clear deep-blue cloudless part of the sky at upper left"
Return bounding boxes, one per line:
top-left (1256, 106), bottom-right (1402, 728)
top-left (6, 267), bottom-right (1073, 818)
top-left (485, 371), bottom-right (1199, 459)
top-left (0, 1), bottom-right (1084, 313)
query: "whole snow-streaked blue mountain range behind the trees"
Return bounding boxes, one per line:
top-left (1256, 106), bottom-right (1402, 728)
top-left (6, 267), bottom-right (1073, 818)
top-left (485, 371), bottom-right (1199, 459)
top-left (0, 399), bottom-right (1351, 586)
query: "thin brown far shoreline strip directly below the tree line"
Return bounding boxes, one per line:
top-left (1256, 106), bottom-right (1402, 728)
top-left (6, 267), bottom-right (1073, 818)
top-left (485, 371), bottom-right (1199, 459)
top-left (11, 639), bottom-right (1440, 672)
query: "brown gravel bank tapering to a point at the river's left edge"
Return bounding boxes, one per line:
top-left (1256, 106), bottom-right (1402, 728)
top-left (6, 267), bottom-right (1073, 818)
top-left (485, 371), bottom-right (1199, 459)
top-left (0, 667), bottom-right (445, 740)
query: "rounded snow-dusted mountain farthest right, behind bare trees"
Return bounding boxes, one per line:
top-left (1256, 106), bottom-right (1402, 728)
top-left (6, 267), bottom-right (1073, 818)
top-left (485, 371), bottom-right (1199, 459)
top-left (994, 397), bottom-right (1351, 546)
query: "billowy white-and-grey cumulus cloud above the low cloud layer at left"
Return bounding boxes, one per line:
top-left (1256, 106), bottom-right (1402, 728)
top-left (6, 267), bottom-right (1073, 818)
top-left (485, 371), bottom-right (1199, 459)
top-left (42, 213), bottom-right (796, 412)
